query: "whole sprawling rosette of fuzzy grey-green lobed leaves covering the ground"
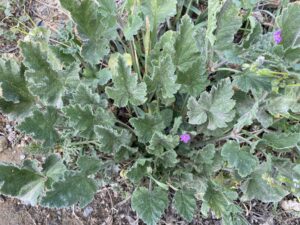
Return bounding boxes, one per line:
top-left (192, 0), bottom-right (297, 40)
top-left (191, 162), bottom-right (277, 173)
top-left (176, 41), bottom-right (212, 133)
top-left (0, 0), bottom-right (300, 225)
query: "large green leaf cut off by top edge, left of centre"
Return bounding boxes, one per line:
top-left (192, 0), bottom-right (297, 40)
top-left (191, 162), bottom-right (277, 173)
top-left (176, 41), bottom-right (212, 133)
top-left (60, 0), bottom-right (117, 64)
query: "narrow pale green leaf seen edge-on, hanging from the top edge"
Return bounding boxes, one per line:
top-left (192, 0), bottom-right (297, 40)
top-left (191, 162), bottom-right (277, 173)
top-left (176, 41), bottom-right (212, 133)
top-left (206, 0), bottom-right (226, 45)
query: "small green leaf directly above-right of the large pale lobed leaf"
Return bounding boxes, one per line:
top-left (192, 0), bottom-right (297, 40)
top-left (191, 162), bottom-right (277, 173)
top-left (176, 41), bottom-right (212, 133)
top-left (233, 70), bottom-right (272, 93)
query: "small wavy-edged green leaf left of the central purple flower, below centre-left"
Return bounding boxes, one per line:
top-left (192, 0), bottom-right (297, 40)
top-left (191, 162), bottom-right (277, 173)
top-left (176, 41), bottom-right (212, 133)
top-left (95, 126), bottom-right (131, 154)
